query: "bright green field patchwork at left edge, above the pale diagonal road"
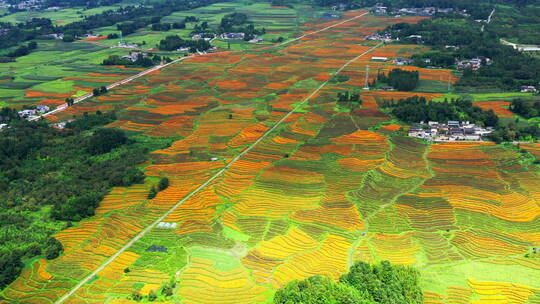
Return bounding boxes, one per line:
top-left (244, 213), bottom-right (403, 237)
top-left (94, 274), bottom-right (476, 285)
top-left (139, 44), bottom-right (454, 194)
top-left (0, 40), bottom-right (146, 106)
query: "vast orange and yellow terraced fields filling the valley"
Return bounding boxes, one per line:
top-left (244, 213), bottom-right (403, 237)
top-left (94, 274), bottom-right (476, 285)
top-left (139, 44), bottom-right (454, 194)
top-left (2, 11), bottom-right (540, 303)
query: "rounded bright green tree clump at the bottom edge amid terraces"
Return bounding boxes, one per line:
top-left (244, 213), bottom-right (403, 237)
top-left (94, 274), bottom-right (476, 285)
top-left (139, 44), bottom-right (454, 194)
top-left (274, 261), bottom-right (423, 304)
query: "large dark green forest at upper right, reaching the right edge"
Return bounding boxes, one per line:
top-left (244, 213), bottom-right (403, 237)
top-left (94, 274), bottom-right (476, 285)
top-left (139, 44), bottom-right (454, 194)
top-left (389, 16), bottom-right (540, 91)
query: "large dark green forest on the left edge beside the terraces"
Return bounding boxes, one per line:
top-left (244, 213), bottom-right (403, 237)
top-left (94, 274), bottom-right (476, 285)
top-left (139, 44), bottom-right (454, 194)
top-left (0, 109), bottom-right (169, 288)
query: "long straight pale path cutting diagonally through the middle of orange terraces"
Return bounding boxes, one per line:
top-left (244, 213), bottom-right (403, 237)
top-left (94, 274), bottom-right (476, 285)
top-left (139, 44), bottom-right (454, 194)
top-left (55, 16), bottom-right (384, 304)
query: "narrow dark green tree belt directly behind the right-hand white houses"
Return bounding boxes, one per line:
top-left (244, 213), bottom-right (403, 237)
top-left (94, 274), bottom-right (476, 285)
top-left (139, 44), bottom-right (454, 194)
top-left (381, 96), bottom-right (499, 127)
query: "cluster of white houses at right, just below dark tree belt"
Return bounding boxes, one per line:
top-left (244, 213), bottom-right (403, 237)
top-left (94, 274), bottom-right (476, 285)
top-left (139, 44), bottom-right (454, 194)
top-left (409, 120), bottom-right (494, 141)
